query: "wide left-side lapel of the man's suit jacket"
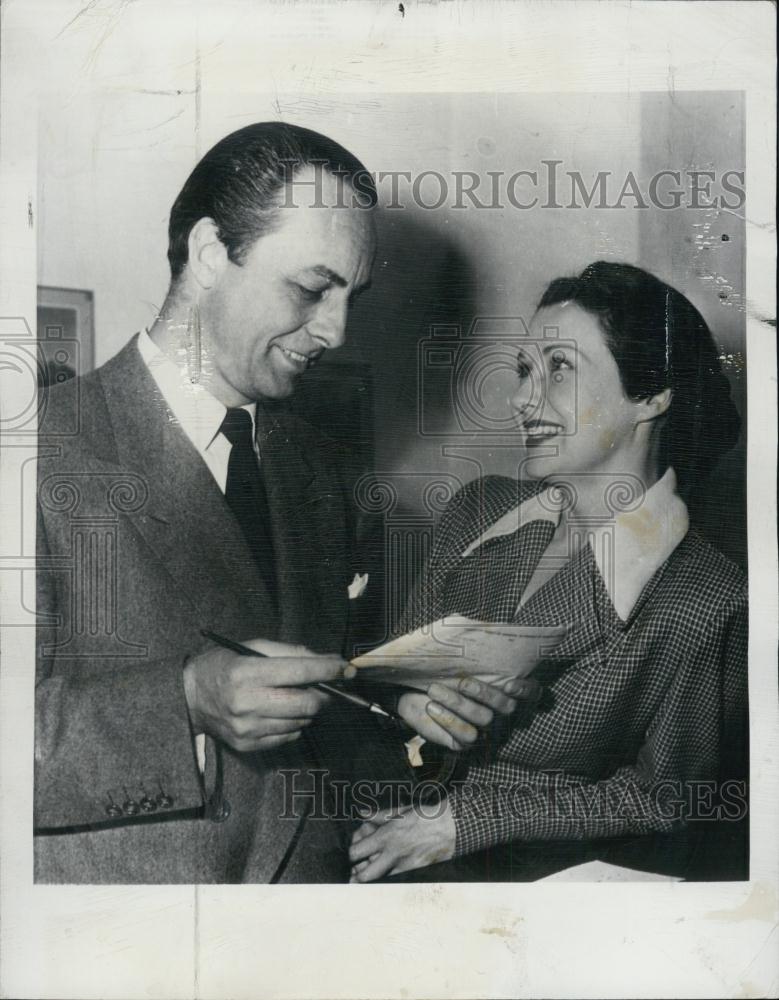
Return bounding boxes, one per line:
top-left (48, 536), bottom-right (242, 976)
top-left (100, 339), bottom-right (277, 638)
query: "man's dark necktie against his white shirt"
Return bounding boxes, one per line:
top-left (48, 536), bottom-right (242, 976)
top-left (219, 408), bottom-right (278, 604)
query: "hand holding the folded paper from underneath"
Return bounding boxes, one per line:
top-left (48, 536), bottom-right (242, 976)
top-left (398, 677), bottom-right (541, 750)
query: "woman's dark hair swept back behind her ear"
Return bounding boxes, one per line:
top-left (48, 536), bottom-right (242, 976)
top-left (538, 261), bottom-right (741, 495)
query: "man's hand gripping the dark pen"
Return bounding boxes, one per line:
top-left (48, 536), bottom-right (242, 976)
top-left (184, 639), bottom-right (353, 752)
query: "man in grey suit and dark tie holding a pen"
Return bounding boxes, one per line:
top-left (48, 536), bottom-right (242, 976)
top-left (35, 123), bottom-right (532, 883)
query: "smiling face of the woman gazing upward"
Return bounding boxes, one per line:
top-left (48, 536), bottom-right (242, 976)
top-left (510, 302), bottom-right (644, 481)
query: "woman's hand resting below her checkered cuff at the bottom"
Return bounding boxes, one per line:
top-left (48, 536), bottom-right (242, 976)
top-left (349, 799), bottom-right (455, 882)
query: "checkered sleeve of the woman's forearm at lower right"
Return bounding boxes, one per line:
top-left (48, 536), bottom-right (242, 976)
top-left (449, 591), bottom-right (747, 856)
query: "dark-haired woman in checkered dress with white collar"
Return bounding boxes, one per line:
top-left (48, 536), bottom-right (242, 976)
top-left (350, 262), bottom-right (747, 881)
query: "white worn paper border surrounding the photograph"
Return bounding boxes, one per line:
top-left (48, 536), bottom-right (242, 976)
top-left (0, 0), bottom-right (779, 1000)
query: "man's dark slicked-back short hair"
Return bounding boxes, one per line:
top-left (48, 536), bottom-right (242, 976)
top-left (168, 122), bottom-right (377, 282)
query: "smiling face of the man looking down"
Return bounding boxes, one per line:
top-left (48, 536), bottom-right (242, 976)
top-left (199, 168), bottom-right (375, 406)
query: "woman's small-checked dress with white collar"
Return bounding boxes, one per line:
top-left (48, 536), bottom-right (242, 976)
top-left (402, 477), bottom-right (747, 855)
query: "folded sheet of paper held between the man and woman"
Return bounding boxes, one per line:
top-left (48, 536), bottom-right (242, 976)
top-left (352, 615), bottom-right (566, 690)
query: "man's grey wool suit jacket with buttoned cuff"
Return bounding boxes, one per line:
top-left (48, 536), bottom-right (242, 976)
top-left (35, 340), bottom-right (354, 883)
